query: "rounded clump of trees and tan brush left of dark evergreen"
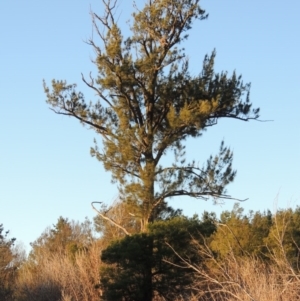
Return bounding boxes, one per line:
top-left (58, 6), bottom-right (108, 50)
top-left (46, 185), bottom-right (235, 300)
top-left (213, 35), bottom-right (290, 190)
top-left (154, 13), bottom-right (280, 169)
top-left (15, 217), bottom-right (101, 301)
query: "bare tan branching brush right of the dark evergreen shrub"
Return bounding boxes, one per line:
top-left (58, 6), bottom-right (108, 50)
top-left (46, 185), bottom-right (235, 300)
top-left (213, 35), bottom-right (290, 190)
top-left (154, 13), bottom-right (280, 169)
top-left (170, 214), bottom-right (300, 301)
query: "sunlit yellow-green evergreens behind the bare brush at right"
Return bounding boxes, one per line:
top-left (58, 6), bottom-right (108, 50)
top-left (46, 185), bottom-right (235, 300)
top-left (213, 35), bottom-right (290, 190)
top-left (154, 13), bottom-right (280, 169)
top-left (210, 204), bottom-right (300, 269)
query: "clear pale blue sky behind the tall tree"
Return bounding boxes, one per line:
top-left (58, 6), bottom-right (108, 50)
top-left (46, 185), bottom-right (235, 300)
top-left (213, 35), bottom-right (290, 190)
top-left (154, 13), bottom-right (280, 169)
top-left (0, 0), bottom-right (300, 249)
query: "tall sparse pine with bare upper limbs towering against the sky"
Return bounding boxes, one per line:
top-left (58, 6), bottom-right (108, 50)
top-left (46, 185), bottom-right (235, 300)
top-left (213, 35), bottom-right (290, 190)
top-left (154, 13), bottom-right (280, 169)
top-left (44, 0), bottom-right (259, 231)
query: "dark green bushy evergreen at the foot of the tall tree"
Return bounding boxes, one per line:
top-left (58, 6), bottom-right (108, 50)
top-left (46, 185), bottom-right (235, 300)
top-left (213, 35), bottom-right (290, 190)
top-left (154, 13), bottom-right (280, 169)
top-left (101, 216), bottom-right (215, 301)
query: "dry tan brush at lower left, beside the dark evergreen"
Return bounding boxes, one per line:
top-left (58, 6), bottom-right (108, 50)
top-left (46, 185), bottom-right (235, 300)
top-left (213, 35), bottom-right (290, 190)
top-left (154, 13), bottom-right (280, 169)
top-left (16, 243), bottom-right (101, 301)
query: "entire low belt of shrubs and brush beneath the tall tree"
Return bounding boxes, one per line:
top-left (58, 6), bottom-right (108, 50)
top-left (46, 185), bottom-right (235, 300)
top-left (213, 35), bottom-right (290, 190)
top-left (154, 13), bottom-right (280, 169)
top-left (0, 204), bottom-right (300, 301)
